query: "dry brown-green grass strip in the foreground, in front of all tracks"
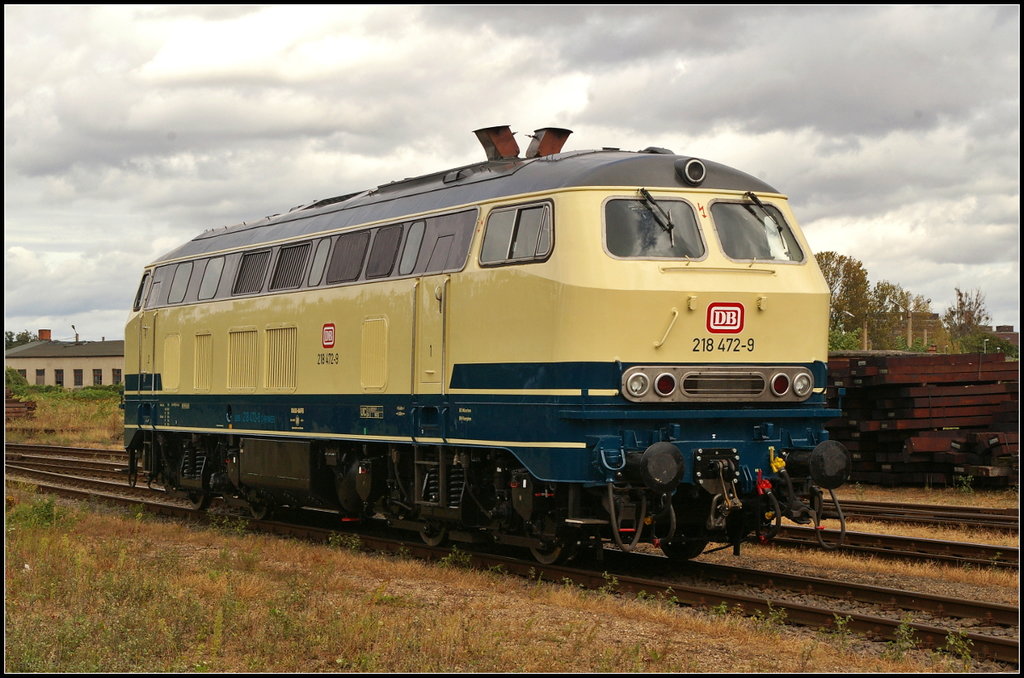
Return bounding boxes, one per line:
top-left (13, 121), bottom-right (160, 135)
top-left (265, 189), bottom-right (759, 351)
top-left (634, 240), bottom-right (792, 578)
top-left (5, 484), bottom-right (991, 673)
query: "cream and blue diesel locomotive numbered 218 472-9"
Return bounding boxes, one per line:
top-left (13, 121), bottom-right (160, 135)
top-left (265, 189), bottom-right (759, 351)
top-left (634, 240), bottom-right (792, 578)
top-left (124, 126), bottom-right (850, 563)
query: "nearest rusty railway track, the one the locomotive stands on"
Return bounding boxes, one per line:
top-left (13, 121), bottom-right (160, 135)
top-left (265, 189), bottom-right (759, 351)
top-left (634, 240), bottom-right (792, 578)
top-left (8, 465), bottom-right (1019, 666)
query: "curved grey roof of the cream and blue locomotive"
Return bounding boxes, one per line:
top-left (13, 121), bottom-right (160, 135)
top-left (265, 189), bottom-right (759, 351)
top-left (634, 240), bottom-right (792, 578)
top-left (154, 147), bottom-right (778, 263)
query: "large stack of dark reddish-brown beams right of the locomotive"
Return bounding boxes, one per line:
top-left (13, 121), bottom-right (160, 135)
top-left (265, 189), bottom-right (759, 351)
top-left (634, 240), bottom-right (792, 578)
top-left (827, 351), bottom-right (1020, 486)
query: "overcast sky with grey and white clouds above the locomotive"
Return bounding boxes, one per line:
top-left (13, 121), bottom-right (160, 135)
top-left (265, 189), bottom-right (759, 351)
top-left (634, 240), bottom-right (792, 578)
top-left (4, 5), bottom-right (1020, 340)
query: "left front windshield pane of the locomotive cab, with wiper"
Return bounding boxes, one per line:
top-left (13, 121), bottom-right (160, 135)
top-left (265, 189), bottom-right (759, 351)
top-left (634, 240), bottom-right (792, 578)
top-left (604, 199), bottom-right (705, 259)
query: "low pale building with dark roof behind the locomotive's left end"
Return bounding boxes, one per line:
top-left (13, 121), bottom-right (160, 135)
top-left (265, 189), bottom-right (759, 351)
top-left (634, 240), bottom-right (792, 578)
top-left (4, 330), bottom-right (125, 388)
